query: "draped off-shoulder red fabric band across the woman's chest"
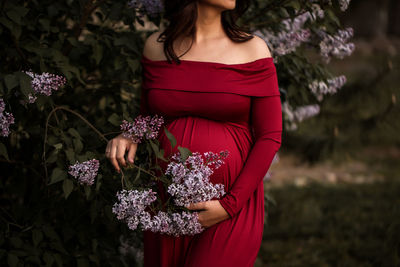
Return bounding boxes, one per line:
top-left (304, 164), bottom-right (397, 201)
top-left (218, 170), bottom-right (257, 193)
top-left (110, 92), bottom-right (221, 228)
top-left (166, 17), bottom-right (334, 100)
top-left (140, 55), bottom-right (280, 97)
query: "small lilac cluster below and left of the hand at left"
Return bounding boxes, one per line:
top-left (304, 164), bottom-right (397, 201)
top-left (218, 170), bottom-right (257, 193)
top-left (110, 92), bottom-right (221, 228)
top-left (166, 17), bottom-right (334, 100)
top-left (68, 159), bottom-right (99, 185)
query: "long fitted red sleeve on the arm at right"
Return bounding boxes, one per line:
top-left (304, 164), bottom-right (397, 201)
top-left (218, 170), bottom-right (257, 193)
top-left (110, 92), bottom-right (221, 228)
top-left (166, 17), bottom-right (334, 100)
top-left (219, 93), bottom-right (282, 218)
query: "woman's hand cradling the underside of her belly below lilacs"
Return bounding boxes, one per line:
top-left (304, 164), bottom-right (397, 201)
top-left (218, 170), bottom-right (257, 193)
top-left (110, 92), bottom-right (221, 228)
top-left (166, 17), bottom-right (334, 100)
top-left (186, 200), bottom-right (230, 228)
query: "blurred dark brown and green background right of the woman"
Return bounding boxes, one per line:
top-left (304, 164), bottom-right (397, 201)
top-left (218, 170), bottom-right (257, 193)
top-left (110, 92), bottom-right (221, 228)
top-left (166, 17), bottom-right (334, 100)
top-left (257, 0), bottom-right (400, 266)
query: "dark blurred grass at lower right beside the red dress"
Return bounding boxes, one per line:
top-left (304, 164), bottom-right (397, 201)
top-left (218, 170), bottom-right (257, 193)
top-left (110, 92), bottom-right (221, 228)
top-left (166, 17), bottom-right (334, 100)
top-left (255, 180), bottom-right (400, 267)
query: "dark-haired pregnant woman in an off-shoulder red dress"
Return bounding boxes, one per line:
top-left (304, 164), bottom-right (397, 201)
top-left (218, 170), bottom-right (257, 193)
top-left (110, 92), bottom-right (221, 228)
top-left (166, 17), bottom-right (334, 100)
top-left (106, 0), bottom-right (282, 267)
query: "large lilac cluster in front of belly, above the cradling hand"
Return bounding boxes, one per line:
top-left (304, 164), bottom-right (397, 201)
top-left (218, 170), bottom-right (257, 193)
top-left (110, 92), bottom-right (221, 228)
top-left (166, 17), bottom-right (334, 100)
top-left (165, 150), bottom-right (228, 206)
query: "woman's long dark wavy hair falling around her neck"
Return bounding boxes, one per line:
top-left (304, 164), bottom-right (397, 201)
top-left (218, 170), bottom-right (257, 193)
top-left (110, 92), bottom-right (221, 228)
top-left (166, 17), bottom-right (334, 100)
top-left (157, 0), bottom-right (254, 64)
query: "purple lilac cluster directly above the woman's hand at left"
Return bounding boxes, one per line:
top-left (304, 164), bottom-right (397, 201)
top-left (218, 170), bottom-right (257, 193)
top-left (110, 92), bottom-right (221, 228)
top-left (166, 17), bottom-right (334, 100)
top-left (120, 114), bottom-right (164, 143)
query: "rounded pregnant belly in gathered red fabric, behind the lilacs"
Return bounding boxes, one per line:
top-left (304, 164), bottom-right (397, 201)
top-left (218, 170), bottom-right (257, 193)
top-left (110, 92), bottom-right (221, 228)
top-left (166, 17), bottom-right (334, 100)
top-left (159, 116), bottom-right (252, 191)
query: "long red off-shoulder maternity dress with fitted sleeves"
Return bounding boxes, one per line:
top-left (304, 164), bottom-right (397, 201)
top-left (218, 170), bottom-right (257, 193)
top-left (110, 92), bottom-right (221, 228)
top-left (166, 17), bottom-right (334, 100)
top-left (141, 52), bottom-right (282, 267)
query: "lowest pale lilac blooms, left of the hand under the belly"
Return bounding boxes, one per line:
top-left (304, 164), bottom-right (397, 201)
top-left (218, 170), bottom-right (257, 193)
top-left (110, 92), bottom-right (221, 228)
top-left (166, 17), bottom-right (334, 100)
top-left (112, 189), bottom-right (204, 236)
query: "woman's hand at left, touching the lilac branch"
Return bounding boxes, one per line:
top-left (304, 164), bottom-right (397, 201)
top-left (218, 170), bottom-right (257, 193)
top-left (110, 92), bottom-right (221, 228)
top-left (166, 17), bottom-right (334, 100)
top-left (105, 134), bottom-right (138, 173)
